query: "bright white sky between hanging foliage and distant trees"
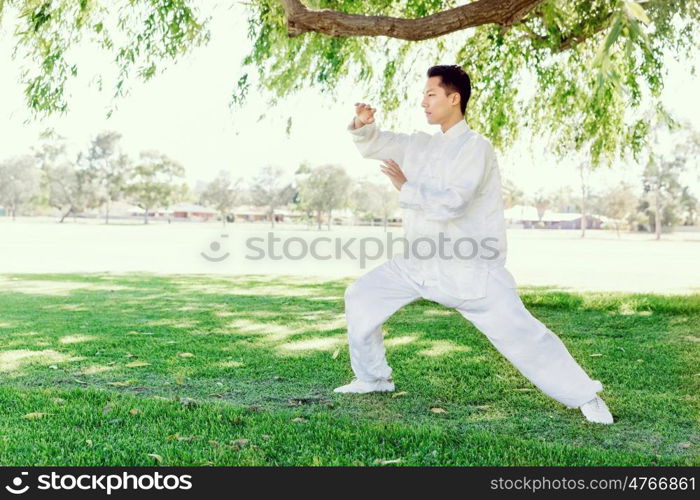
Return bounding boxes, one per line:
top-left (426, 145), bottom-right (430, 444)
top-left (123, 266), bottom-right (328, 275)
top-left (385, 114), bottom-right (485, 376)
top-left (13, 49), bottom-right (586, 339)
top-left (0, 3), bottom-right (700, 200)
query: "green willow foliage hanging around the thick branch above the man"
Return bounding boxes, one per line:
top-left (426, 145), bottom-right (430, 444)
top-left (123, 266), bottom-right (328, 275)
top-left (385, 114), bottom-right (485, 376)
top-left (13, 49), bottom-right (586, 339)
top-left (236, 0), bottom-right (697, 165)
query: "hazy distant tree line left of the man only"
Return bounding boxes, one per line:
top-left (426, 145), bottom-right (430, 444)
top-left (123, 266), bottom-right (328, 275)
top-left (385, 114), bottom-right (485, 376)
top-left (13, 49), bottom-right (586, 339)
top-left (0, 131), bottom-right (398, 229)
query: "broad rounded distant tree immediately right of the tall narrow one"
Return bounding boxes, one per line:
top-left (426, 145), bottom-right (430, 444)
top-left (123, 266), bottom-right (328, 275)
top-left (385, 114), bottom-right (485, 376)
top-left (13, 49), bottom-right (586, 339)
top-left (124, 151), bottom-right (187, 224)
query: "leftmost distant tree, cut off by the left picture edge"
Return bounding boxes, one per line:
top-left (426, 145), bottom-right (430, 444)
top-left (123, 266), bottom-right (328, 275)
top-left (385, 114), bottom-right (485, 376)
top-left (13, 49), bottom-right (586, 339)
top-left (0, 155), bottom-right (41, 220)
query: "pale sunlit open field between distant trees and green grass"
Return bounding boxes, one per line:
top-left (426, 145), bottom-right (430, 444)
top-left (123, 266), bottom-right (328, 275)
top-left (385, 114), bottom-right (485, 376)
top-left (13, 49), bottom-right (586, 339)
top-left (0, 218), bottom-right (700, 294)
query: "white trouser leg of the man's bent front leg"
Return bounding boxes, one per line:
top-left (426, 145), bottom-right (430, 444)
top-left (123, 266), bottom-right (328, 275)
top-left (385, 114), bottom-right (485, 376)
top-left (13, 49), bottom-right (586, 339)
top-left (345, 260), bottom-right (420, 382)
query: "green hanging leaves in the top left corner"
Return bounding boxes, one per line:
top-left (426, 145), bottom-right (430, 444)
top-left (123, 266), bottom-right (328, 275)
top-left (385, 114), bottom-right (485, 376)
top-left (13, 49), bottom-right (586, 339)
top-left (8, 0), bottom-right (209, 117)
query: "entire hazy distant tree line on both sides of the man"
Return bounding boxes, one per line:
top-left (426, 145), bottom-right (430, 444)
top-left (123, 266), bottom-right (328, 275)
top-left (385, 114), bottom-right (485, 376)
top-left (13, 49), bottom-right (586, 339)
top-left (0, 126), bottom-right (700, 237)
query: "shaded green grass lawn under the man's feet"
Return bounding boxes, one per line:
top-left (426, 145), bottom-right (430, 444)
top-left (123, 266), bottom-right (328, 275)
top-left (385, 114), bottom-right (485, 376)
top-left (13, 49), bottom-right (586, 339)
top-left (0, 274), bottom-right (700, 465)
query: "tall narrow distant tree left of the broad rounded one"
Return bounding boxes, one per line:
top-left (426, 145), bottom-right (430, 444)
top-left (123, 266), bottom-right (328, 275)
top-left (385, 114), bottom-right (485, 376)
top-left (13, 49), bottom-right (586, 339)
top-left (83, 131), bottom-right (131, 224)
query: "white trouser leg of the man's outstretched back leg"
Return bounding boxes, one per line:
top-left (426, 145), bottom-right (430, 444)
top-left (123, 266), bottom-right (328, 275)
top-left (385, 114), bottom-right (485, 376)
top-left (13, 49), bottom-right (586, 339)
top-left (456, 278), bottom-right (603, 408)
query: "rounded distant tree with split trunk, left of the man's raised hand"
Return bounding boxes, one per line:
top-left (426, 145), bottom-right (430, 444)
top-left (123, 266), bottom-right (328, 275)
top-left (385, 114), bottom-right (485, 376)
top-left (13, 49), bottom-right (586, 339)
top-left (297, 165), bottom-right (352, 229)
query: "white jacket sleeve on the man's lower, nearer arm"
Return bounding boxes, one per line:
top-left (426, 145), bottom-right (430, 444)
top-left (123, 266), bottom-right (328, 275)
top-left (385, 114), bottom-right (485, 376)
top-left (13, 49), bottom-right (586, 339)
top-left (399, 139), bottom-right (495, 221)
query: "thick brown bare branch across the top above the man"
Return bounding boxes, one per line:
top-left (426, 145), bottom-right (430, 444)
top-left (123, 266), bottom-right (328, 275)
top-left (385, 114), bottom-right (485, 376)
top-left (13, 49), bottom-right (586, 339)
top-left (279, 0), bottom-right (543, 41)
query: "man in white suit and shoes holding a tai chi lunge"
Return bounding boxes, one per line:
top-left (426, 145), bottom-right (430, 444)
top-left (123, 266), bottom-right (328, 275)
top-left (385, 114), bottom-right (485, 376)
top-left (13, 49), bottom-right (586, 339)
top-left (335, 65), bottom-right (613, 424)
